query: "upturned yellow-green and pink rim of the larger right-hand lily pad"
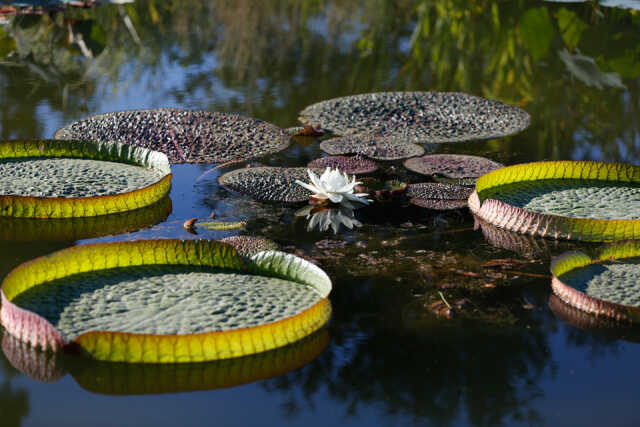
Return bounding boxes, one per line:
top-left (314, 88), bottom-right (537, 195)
top-left (468, 160), bottom-right (640, 242)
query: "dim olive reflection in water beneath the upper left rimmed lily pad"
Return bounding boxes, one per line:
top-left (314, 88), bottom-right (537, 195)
top-left (0, 196), bottom-right (172, 242)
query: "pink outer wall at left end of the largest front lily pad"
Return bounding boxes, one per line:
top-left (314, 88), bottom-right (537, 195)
top-left (0, 291), bottom-right (65, 351)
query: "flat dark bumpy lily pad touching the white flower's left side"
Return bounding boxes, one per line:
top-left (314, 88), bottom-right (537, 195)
top-left (218, 166), bottom-right (322, 203)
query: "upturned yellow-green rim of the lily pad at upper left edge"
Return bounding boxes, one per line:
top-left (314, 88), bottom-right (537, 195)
top-left (0, 139), bottom-right (172, 218)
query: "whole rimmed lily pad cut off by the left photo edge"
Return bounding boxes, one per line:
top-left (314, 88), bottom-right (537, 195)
top-left (0, 140), bottom-right (171, 218)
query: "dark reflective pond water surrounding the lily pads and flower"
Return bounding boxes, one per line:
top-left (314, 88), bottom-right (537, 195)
top-left (0, 0), bottom-right (640, 426)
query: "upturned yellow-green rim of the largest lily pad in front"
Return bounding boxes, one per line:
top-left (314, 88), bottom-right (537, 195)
top-left (0, 240), bottom-right (331, 363)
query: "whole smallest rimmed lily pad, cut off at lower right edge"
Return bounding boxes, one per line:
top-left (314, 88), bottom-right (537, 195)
top-left (551, 241), bottom-right (640, 323)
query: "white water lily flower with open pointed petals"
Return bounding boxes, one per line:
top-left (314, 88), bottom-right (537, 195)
top-left (296, 168), bottom-right (371, 205)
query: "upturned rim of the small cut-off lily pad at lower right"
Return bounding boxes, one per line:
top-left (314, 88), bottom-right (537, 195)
top-left (551, 241), bottom-right (640, 324)
